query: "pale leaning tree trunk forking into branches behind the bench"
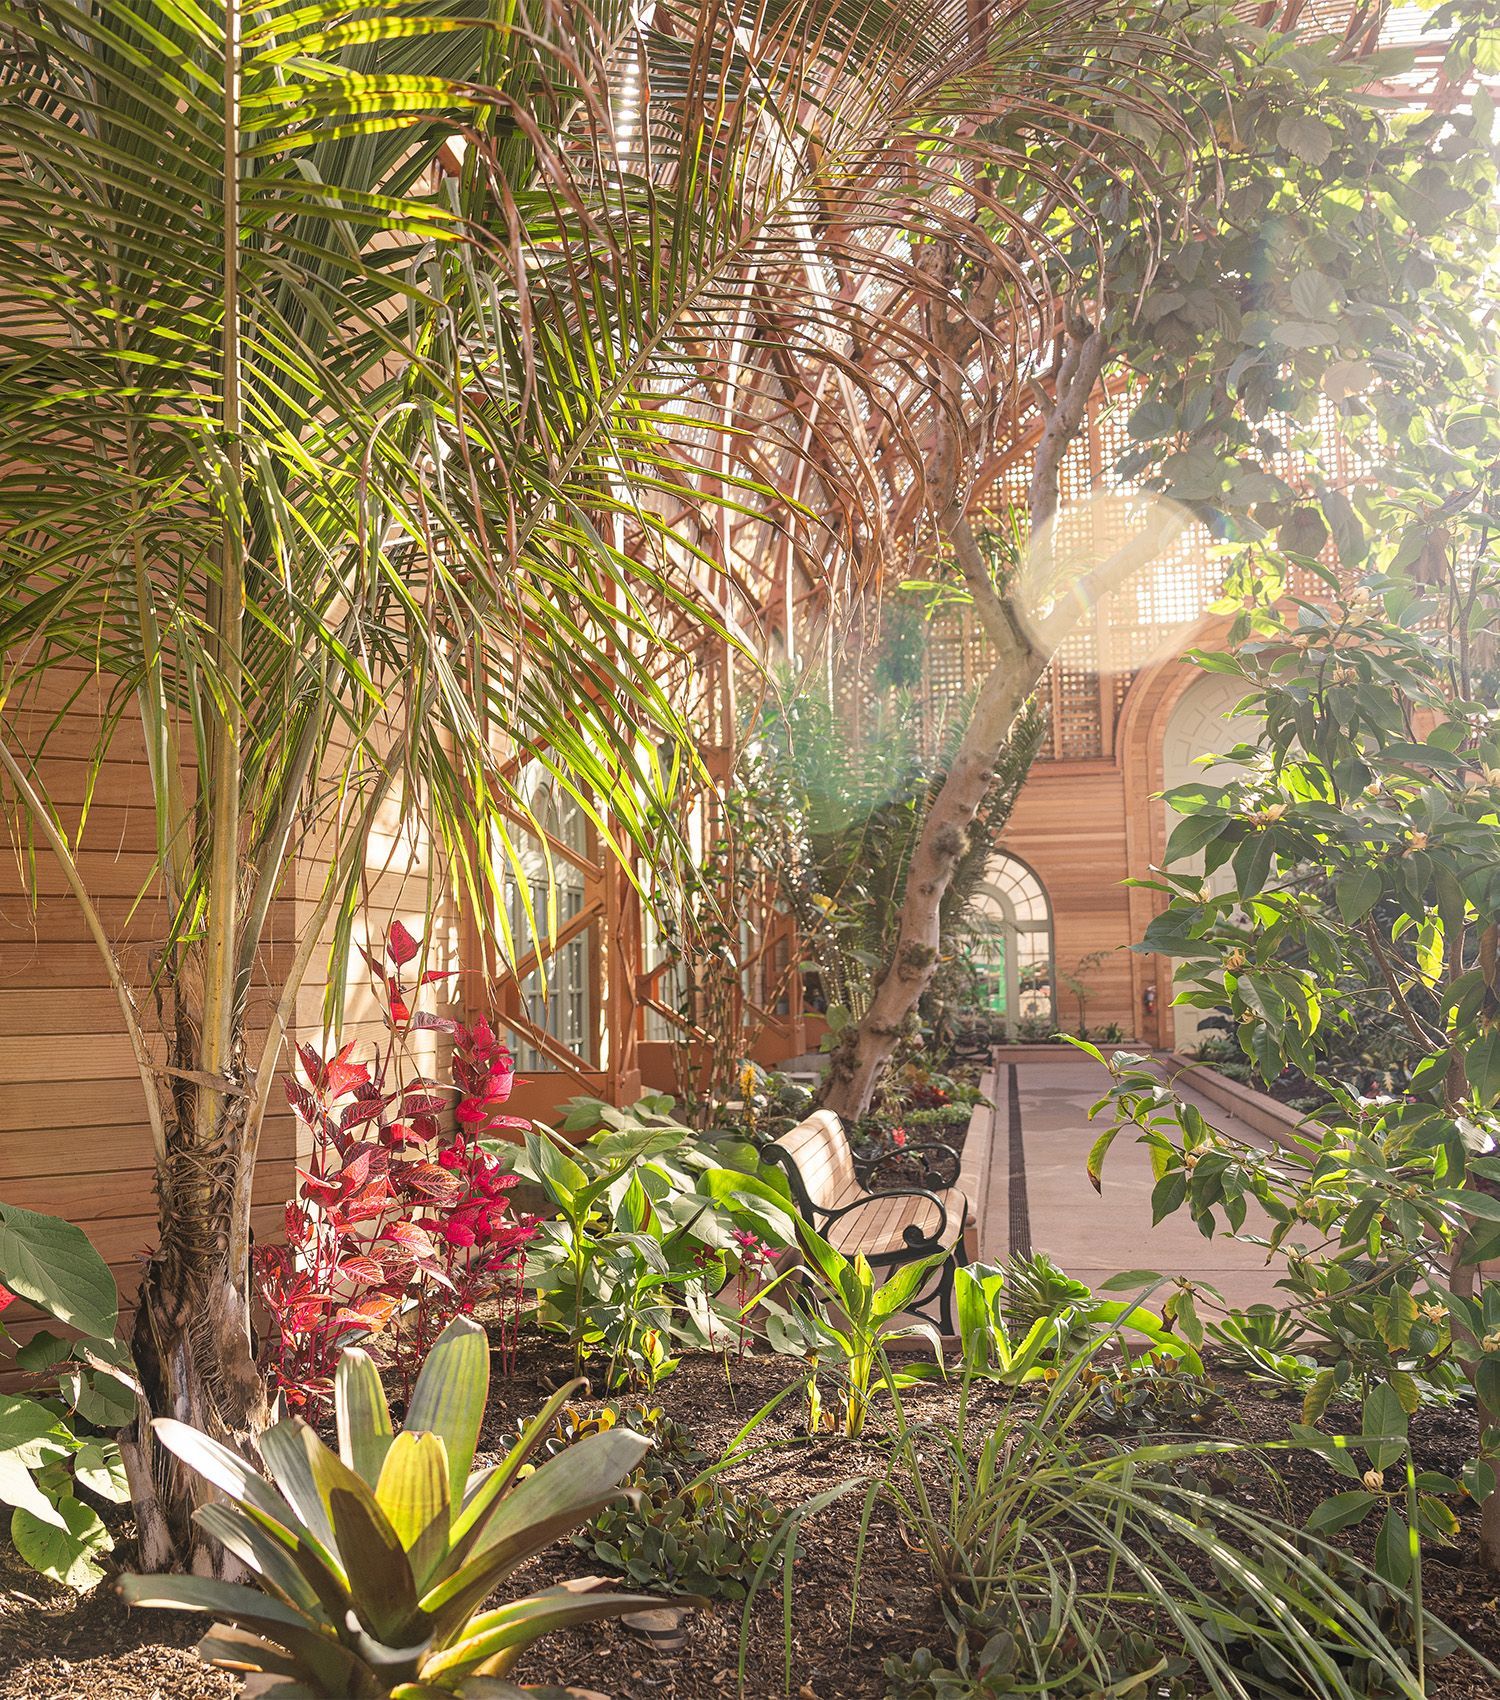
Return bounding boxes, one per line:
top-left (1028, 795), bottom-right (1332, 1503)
top-left (821, 320), bottom-right (1185, 1119)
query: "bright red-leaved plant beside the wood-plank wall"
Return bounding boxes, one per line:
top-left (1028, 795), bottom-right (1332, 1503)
top-left (255, 921), bottom-right (536, 1413)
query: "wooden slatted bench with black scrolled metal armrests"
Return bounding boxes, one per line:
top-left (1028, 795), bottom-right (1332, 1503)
top-left (760, 1110), bottom-right (969, 1335)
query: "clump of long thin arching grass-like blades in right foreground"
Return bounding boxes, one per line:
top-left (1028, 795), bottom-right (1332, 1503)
top-left (855, 1343), bottom-right (1500, 1700)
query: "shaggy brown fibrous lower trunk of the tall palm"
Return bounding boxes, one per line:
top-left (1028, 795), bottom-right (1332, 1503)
top-left (121, 999), bottom-right (270, 1576)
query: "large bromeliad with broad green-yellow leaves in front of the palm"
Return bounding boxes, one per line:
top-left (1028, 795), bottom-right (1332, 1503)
top-left (121, 1318), bottom-right (683, 1700)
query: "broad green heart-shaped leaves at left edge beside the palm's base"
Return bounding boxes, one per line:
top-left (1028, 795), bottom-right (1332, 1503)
top-left (0, 1204), bottom-right (138, 1588)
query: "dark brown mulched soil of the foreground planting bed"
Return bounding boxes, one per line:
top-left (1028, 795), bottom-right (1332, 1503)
top-left (0, 1346), bottom-right (1500, 1700)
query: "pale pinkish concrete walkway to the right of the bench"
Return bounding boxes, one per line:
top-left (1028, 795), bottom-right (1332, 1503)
top-left (980, 1052), bottom-right (1281, 1306)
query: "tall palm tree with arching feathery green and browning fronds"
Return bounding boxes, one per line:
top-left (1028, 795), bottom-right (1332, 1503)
top-left (0, 0), bottom-right (1190, 1566)
